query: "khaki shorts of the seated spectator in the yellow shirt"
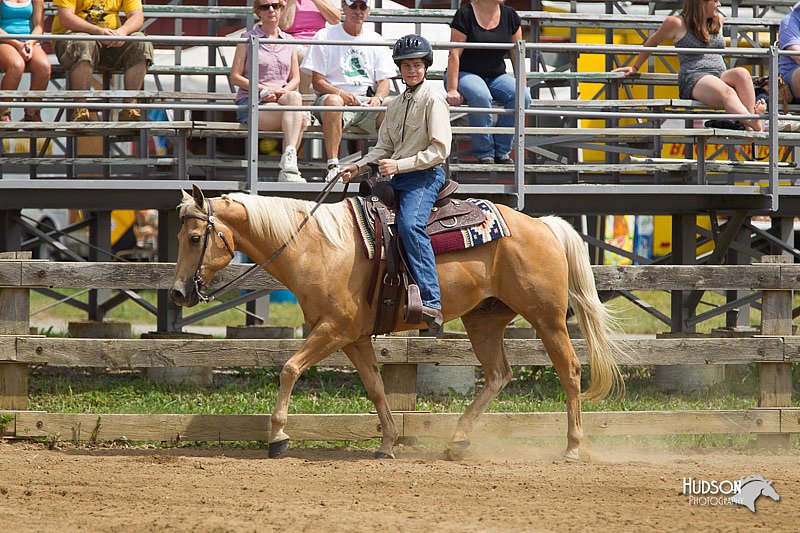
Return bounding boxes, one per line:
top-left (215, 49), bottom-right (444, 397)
top-left (56, 31), bottom-right (153, 70)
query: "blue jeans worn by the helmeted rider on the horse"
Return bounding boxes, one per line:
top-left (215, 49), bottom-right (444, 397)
top-left (392, 165), bottom-right (444, 309)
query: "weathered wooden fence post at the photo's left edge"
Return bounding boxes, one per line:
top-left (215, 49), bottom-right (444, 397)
top-left (0, 252), bottom-right (31, 410)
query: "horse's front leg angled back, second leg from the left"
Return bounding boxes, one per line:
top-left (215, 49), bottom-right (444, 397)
top-left (342, 337), bottom-right (398, 459)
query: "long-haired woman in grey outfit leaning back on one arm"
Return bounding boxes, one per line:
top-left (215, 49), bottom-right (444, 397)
top-left (614, 0), bottom-right (767, 131)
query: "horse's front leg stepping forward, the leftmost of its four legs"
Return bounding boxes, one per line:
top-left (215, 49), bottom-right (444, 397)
top-left (268, 325), bottom-right (346, 458)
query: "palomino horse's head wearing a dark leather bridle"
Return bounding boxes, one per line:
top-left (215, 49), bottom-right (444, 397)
top-left (169, 185), bottom-right (234, 307)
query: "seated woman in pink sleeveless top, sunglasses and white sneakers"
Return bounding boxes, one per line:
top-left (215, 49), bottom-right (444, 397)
top-left (231, 0), bottom-right (306, 183)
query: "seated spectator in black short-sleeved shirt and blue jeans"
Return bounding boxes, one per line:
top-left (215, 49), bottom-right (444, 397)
top-left (445, 0), bottom-right (531, 165)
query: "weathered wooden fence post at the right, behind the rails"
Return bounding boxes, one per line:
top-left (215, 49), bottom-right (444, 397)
top-left (756, 255), bottom-right (792, 448)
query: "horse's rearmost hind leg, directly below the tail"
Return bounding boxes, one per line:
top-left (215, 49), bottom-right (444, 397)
top-left (536, 313), bottom-right (583, 461)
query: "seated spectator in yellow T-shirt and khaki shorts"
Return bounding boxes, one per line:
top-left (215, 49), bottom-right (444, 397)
top-left (53, 0), bottom-right (153, 121)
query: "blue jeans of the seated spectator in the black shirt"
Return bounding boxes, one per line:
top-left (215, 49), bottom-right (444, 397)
top-left (445, 72), bottom-right (531, 159)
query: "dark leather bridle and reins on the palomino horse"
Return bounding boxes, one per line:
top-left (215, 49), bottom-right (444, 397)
top-left (181, 176), bottom-right (350, 303)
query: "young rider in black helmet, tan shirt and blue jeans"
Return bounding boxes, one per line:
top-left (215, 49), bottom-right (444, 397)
top-left (340, 34), bottom-right (453, 327)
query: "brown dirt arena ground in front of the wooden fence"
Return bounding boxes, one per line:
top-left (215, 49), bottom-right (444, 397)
top-left (0, 442), bottom-right (800, 532)
